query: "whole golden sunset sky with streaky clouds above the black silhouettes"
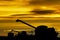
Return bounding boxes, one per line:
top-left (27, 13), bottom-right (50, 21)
top-left (0, 0), bottom-right (60, 36)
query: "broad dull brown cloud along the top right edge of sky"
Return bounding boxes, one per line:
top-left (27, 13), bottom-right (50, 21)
top-left (30, 0), bottom-right (60, 5)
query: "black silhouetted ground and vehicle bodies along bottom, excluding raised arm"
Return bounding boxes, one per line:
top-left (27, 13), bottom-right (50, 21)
top-left (0, 25), bottom-right (60, 40)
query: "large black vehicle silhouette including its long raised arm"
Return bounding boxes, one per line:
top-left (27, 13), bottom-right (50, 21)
top-left (16, 19), bottom-right (58, 40)
